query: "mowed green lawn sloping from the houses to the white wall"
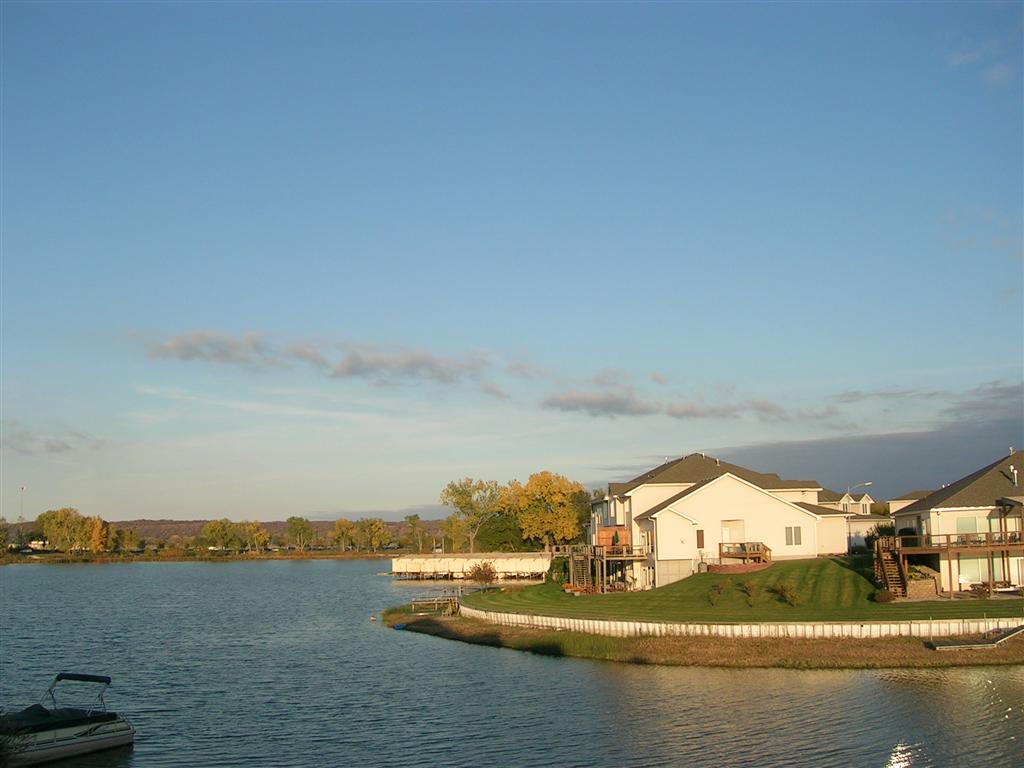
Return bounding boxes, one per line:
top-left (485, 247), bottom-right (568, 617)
top-left (464, 558), bottom-right (1024, 623)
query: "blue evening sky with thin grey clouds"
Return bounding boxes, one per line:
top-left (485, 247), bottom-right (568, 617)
top-left (0, 2), bottom-right (1024, 520)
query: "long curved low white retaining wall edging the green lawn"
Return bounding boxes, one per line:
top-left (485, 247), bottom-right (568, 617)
top-left (459, 605), bottom-right (1024, 639)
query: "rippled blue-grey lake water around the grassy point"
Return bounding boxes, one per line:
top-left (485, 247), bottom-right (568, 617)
top-left (0, 560), bottom-right (1024, 768)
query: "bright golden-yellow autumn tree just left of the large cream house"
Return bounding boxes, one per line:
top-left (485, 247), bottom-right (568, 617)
top-left (506, 471), bottom-right (590, 549)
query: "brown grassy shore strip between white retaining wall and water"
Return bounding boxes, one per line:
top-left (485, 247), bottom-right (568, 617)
top-left (382, 606), bottom-right (1024, 670)
